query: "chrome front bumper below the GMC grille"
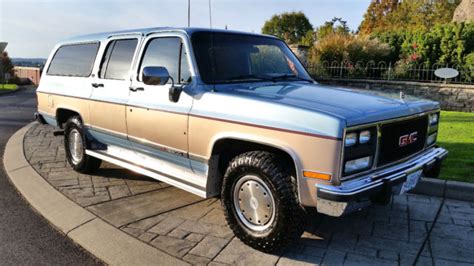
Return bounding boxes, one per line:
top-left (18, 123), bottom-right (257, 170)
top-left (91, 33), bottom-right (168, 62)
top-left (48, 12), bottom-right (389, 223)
top-left (316, 147), bottom-right (448, 216)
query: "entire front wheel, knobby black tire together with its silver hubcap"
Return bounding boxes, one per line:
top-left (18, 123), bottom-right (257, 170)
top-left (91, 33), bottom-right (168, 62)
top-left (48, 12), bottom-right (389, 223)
top-left (221, 151), bottom-right (304, 252)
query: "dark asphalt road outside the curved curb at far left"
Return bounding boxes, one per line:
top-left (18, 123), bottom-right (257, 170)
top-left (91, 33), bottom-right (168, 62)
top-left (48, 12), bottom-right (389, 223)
top-left (0, 89), bottom-right (97, 265)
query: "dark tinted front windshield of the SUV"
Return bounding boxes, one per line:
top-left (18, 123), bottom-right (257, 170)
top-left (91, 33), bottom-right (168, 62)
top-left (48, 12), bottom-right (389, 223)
top-left (191, 32), bottom-right (311, 84)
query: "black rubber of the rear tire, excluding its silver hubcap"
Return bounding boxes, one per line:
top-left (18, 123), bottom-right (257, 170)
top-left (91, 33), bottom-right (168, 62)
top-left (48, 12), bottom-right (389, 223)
top-left (64, 116), bottom-right (102, 174)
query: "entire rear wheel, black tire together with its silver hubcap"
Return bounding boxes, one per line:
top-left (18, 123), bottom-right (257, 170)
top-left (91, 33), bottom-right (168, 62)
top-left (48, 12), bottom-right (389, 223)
top-left (64, 116), bottom-right (102, 173)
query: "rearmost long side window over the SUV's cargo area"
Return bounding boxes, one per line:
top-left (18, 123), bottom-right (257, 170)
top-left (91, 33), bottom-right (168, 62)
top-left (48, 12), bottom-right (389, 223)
top-left (47, 43), bottom-right (99, 77)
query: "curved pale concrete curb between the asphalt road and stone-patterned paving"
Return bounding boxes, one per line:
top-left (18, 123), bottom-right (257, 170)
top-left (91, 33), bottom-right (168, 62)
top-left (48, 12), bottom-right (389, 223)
top-left (3, 123), bottom-right (186, 265)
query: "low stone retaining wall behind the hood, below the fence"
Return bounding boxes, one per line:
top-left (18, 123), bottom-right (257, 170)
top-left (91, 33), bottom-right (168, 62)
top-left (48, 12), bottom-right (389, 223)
top-left (318, 79), bottom-right (474, 112)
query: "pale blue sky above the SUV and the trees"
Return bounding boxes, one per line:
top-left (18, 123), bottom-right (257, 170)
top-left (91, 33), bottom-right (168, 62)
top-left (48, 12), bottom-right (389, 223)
top-left (0, 0), bottom-right (370, 58)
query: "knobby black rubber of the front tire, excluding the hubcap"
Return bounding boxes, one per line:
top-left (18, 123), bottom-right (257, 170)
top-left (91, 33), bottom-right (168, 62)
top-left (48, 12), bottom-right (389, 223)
top-left (221, 151), bottom-right (305, 252)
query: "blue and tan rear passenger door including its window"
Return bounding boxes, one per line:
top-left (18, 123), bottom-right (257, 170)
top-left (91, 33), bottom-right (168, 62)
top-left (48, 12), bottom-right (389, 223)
top-left (90, 35), bottom-right (141, 147)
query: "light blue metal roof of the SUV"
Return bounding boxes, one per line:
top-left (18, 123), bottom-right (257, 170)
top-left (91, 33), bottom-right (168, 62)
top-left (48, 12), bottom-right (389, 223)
top-left (61, 27), bottom-right (275, 43)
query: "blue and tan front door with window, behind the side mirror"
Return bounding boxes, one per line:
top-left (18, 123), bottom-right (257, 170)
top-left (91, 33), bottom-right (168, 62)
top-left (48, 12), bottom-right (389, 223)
top-left (126, 34), bottom-right (193, 170)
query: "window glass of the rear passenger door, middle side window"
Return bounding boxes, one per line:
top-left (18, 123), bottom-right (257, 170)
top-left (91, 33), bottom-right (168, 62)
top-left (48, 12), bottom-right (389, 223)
top-left (99, 39), bottom-right (138, 80)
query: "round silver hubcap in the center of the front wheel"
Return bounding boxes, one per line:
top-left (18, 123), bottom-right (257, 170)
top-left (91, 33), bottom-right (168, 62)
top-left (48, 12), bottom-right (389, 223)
top-left (234, 175), bottom-right (275, 231)
